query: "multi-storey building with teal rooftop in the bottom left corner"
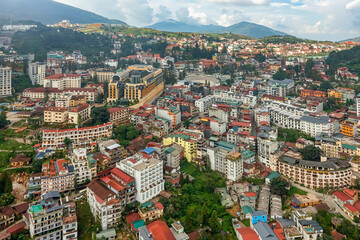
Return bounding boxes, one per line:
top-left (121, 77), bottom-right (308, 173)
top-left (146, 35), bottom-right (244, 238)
top-left (26, 191), bottom-right (77, 240)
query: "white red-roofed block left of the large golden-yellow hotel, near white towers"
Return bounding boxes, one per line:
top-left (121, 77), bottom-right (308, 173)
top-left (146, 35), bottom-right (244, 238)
top-left (44, 74), bottom-right (81, 90)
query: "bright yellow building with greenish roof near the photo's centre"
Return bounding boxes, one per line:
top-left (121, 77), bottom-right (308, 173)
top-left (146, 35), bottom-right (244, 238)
top-left (163, 134), bottom-right (197, 162)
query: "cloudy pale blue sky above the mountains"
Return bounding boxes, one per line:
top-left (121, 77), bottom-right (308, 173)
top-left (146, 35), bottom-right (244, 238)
top-left (55, 0), bottom-right (360, 41)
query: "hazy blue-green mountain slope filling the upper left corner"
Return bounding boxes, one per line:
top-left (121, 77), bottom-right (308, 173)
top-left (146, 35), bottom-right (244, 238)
top-left (0, 0), bottom-right (127, 26)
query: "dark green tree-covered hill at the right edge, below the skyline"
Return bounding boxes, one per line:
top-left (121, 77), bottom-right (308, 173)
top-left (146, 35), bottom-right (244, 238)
top-left (326, 46), bottom-right (360, 76)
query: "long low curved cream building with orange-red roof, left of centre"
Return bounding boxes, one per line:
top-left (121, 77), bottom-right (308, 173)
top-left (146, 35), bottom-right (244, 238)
top-left (42, 123), bottom-right (113, 149)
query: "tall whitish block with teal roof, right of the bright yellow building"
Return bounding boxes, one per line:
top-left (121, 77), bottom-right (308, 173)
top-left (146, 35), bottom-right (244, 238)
top-left (207, 141), bottom-right (243, 181)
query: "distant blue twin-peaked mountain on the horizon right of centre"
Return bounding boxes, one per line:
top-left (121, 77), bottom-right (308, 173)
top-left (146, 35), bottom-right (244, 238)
top-left (147, 19), bottom-right (287, 38)
